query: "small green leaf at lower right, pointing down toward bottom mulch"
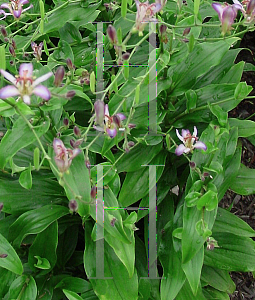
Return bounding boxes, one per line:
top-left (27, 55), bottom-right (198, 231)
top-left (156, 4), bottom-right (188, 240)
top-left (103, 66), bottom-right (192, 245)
top-left (201, 265), bottom-right (236, 294)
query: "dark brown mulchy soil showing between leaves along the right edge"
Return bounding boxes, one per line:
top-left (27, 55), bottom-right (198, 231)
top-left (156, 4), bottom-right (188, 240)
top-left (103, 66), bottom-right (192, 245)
top-left (220, 32), bottom-right (255, 300)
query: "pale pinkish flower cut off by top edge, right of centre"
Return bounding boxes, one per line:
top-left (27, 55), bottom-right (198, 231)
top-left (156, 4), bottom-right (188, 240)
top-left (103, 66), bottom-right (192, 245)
top-left (135, 0), bottom-right (163, 35)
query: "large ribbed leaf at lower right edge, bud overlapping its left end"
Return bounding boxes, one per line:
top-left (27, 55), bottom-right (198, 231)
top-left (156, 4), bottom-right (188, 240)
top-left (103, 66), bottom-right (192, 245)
top-left (204, 232), bottom-right (255, 272)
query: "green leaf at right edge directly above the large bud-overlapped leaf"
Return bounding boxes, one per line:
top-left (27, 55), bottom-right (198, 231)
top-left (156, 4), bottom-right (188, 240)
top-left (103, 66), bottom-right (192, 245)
top-left (212, 207), bottom-right (255, 237)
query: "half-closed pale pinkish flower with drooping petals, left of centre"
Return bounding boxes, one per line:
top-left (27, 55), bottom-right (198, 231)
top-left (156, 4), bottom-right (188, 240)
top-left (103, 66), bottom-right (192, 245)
top-left (53, 138), bottom-right (81, 173)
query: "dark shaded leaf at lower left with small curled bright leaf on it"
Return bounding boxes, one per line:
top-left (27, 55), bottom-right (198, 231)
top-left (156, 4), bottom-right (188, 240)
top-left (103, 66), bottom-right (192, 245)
top-left (28, 221), bottom-right (58, 275)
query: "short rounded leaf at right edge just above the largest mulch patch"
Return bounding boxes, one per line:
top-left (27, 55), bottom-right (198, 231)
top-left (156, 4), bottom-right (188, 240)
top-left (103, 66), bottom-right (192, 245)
top-left (230, 164), bottom-right (255, 195)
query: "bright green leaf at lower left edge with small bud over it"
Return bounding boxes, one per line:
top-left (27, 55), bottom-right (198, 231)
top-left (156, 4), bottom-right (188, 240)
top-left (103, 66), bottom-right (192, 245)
top-left (0, 234), bottom-right (23, 275)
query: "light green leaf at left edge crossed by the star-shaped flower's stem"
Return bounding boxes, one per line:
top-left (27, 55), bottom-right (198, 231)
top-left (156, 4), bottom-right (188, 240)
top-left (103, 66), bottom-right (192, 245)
top-left (0, 117), bottom-right (50, 169)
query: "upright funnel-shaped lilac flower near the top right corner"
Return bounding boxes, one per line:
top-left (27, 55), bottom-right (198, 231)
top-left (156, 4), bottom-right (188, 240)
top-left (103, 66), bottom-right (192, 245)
top-left (212, 3), bottom-right (242, 35)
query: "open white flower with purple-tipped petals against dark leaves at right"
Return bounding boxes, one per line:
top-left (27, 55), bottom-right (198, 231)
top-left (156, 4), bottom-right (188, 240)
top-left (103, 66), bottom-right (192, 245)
top-left (175, 126), bottom-right (207, 156)
